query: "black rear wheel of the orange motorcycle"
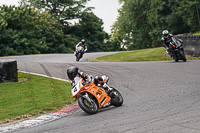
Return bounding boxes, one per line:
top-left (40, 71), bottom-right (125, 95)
top-left (110, 88), bottom-right (123, 107)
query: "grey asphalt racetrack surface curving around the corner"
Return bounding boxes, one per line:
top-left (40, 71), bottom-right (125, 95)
top-left (0, 53), bottom-right (200, 133)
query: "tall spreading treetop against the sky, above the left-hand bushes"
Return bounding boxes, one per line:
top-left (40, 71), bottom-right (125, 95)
top-left (21, 0), bottom-right (91, 27)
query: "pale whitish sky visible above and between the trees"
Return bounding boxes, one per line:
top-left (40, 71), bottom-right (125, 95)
top-left (0, 0), bottom-right (121, 33)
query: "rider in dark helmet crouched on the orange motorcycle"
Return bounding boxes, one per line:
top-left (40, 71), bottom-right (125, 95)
top-left (67, 66), bottom-right (108, 89)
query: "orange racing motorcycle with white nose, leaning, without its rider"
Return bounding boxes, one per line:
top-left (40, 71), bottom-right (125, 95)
top-left (71, 75), bottom-right (123, 114)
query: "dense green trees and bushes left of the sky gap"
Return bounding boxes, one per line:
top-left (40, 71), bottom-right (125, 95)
top-left (0, 0), bottom-right (108, 56)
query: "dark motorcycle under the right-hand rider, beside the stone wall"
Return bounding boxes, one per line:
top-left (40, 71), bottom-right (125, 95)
top-left (169, 38), bottom-right (187, 62)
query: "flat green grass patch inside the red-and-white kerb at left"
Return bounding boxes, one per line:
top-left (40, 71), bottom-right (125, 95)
top-left (0, 72), bottom-right (75, 123)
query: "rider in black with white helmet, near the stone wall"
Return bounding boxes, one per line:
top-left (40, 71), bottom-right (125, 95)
top-left (162, 30), bottom-right (183, 56)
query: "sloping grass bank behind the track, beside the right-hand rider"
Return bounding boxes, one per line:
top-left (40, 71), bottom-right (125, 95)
top-left (89, 47), bottom-right (200, 62)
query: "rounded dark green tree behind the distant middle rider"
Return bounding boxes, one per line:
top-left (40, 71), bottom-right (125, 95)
top-left (69, 12), bottom-right (108, 52)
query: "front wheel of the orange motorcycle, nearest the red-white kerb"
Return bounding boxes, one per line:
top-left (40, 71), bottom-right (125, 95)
top-left (78, 96), bottom-right (98, 114)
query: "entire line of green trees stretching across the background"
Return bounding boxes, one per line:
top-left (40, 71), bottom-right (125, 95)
top-left (0, 0), bottom-right (200, 56)
